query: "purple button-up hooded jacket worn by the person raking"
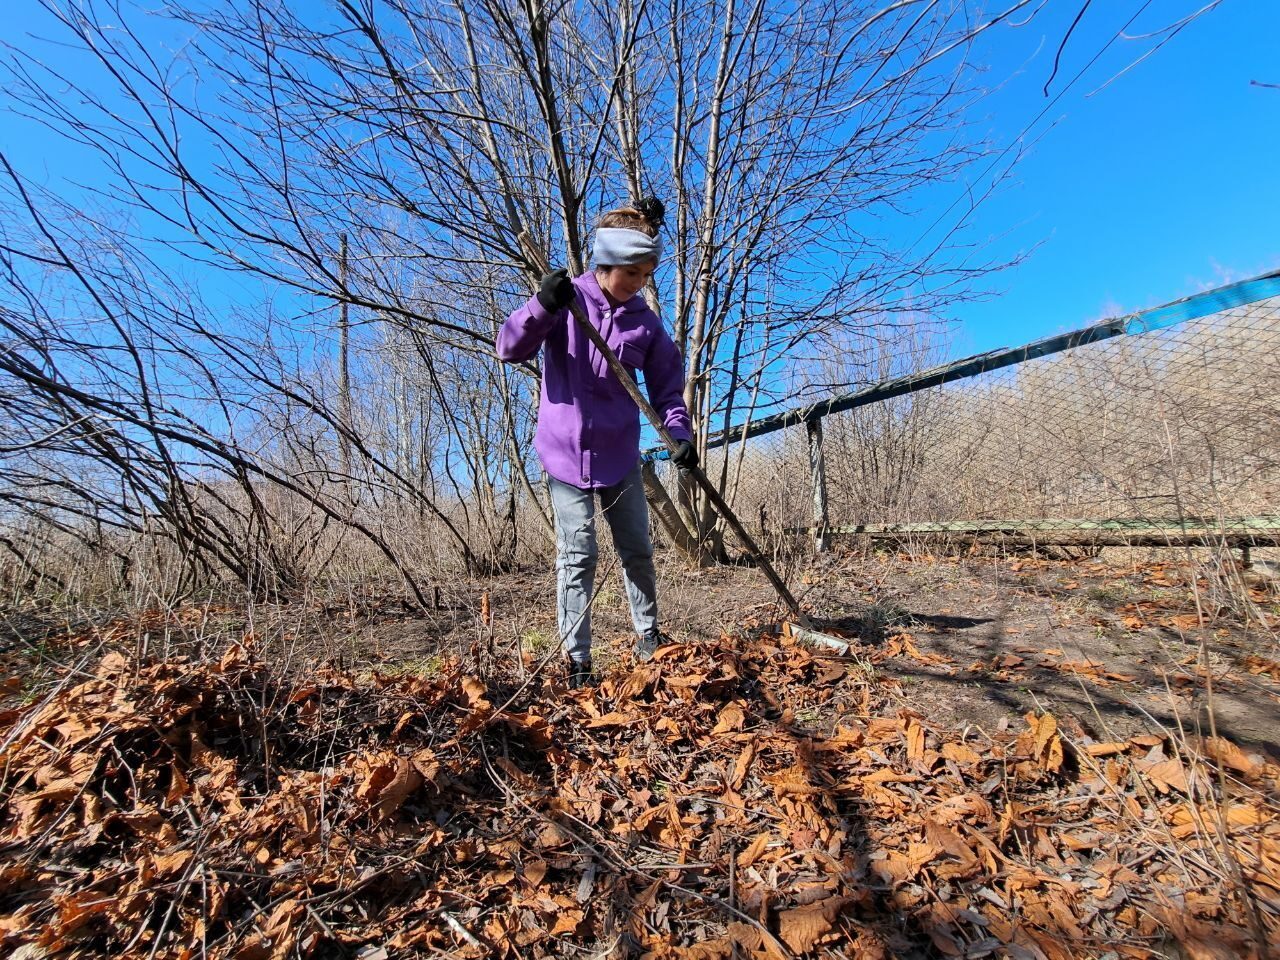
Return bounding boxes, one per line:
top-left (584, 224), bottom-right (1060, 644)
top-left (498, 271), bottom-right (692, 489)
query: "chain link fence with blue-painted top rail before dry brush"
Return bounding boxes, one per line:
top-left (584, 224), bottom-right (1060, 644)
top-left (650, 274), bottom-right (1280, 548)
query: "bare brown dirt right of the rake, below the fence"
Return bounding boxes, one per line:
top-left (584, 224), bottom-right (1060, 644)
top-left (793, 550), bottom-right (1280, 753)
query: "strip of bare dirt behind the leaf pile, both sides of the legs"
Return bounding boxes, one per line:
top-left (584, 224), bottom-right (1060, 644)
top-left (127, 549), bottom-right (1280, 756)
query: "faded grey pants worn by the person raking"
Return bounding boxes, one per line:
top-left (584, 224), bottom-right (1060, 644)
top-left (548, 462), bottom-right (658, 662)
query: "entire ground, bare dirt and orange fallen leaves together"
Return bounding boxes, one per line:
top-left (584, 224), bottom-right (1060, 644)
top-left (0, 550), bottom-right (1280, 960)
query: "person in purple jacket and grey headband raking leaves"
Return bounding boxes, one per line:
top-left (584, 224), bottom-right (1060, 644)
top-left (498, 198), bottom-right (698, 687)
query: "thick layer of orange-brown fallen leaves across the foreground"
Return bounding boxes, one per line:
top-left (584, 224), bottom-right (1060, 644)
top-left (0, 619), bottom-right (1280, 960)
